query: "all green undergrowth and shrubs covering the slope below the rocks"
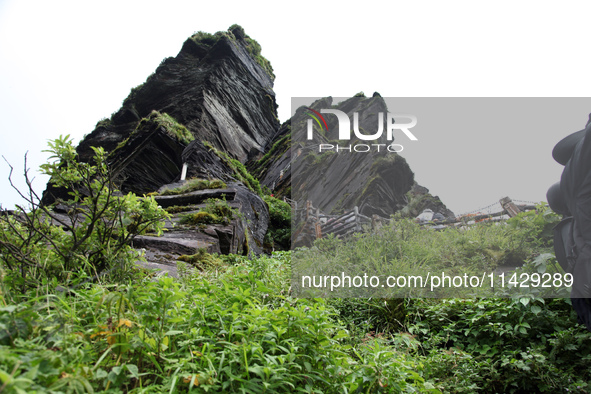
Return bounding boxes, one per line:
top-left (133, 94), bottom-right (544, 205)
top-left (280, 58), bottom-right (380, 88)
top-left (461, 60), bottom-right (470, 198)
top-left (0, 139), bottom-right (591, 393)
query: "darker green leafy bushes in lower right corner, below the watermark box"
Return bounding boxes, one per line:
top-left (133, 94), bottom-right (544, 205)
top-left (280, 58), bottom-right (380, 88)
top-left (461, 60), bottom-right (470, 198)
top-left (409, 298), bottom-right (591, 392)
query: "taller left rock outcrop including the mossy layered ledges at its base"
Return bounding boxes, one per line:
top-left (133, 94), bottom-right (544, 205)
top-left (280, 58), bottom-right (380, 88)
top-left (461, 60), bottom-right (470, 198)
top-left (44, 25), bottom-right (280, 270)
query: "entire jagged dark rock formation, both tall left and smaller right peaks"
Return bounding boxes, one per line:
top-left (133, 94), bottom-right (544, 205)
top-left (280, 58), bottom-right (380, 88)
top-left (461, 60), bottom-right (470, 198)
top-left (44, 25), bottom-right (454, 263)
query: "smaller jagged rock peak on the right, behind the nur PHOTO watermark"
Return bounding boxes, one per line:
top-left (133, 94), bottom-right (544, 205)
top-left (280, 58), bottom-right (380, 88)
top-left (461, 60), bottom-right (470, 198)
top-left (247, 94), bottom-right (453, 217)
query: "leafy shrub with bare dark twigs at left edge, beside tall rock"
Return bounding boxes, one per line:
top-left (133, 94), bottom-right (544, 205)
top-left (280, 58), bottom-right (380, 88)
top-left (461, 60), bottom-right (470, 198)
top-left (0, 136), bottom-right (168, 291)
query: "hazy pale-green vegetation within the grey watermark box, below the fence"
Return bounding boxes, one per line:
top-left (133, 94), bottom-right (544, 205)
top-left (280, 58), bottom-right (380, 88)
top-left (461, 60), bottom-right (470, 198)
top-left (293, 205), bottom-right (568, 297)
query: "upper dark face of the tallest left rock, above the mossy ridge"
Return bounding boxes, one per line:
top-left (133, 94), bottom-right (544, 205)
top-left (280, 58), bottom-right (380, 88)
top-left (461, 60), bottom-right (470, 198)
top-left (78, 27), bottom-right (279, 165)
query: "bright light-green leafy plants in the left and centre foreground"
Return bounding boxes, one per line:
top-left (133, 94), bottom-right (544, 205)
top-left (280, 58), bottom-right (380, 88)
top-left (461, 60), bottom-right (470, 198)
top-left (0, 253), bottom-right (436, 393)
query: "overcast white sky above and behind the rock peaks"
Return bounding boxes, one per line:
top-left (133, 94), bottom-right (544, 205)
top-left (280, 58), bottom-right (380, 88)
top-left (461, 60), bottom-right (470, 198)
top-left (0, 0), bottom-right (591, 213)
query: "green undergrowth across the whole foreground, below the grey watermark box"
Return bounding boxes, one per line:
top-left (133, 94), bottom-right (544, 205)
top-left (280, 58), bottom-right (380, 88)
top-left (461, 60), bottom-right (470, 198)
top-left (0, 252), bottom-right (591, 393)
